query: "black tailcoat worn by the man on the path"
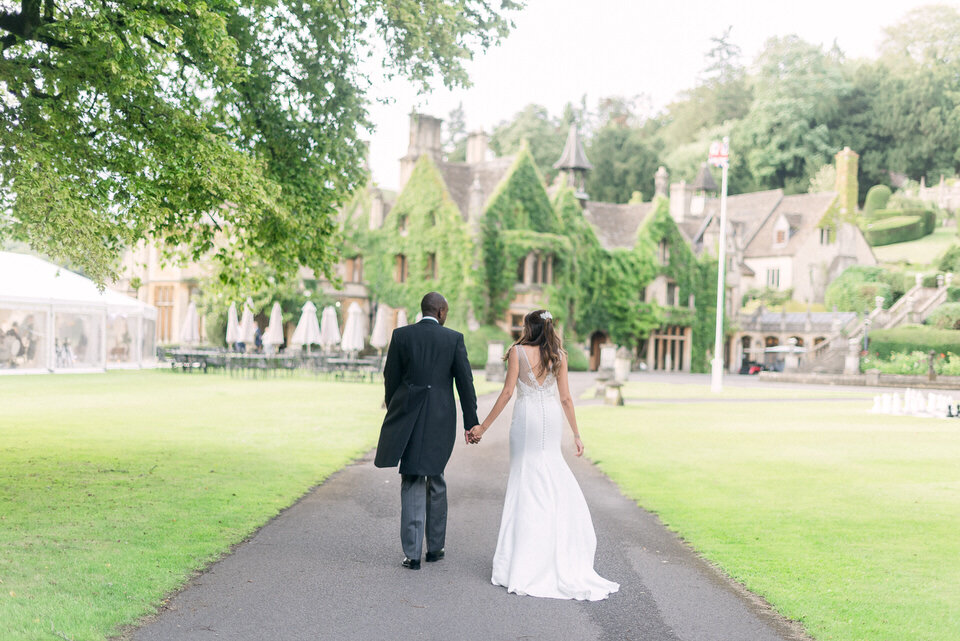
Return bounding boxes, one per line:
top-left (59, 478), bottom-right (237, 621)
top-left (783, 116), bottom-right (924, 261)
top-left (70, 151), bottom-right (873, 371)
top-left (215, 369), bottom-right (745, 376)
top-left (374, 319), bottom-right (479, 476)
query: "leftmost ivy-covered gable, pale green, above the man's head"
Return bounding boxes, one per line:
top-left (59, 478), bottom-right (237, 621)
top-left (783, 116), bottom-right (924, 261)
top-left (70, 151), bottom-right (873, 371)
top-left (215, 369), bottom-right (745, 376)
top-left (358, 155), bottom-right (474, 329)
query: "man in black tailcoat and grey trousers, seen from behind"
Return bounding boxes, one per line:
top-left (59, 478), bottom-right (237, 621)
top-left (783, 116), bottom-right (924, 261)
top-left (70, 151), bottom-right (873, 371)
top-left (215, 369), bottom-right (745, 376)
top-left (374, 292), bottom-right (480, 570)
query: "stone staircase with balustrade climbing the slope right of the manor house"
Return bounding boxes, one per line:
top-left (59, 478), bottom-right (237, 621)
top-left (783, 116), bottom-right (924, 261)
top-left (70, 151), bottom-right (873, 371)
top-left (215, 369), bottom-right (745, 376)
top-left (800, 274), bottom-right (953, 373)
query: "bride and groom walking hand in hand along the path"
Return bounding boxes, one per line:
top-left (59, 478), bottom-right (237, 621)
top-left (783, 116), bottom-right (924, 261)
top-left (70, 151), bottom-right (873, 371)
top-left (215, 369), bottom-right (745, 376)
top-left (375, 292), bottom-right (620, 601)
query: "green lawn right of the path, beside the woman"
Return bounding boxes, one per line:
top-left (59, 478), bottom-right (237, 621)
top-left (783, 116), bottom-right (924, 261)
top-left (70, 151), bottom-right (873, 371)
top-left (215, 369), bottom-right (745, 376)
top-left (578, 396), bottom-right (960, 641)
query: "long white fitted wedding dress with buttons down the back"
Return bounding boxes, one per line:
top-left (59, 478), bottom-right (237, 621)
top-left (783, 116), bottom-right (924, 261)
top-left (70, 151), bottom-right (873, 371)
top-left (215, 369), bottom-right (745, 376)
top-left (492, 345), bottom-right (620, 601)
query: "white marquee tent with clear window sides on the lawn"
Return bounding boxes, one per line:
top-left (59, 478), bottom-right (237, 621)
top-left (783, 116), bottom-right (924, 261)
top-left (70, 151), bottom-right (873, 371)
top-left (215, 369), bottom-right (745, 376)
top-left (0, 252), bottom-right (157, 374)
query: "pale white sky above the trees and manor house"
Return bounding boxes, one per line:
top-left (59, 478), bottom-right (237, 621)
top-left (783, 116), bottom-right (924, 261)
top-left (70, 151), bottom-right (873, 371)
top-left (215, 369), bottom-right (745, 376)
top-left (370, 0), bottom-right (956, 189)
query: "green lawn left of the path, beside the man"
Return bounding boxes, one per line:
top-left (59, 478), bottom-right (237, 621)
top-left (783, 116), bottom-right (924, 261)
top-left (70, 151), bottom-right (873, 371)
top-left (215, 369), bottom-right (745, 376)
top-left (0, 371), bottom-right (383, 641)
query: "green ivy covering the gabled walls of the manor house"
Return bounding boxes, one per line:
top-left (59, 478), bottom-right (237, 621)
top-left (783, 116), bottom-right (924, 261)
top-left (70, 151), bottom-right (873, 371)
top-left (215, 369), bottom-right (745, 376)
top-left (344, 148), bottom-right (716, 371)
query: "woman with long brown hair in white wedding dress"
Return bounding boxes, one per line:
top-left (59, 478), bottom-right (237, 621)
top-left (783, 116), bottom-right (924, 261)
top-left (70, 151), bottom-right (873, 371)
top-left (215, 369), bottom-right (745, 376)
top-left (470, 310), bottom-right (620, 601)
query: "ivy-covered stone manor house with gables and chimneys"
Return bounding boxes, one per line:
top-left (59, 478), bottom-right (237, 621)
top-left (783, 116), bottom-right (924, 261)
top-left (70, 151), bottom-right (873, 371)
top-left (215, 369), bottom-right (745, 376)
top-left (120, 113), bottom-right (876, 371)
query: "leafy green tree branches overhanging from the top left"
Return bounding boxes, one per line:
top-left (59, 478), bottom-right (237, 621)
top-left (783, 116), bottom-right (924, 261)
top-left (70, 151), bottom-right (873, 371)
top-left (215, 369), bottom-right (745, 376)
top-left (0, 0), bottom-right (519, 282)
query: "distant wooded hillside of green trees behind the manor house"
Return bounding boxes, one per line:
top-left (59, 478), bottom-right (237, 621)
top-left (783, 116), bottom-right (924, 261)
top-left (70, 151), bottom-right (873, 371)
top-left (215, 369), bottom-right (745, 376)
top-left (447, 5), bottom-right (960, 202)
